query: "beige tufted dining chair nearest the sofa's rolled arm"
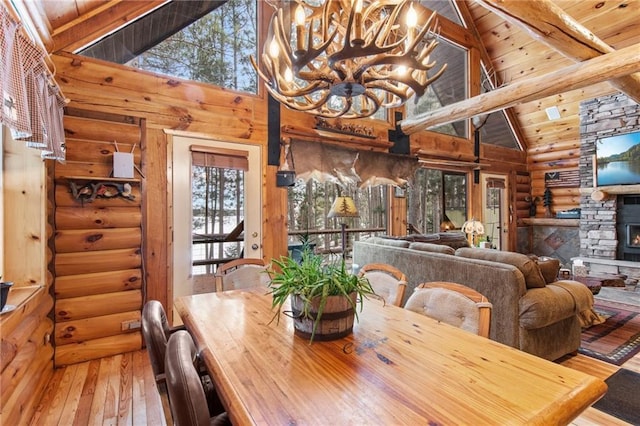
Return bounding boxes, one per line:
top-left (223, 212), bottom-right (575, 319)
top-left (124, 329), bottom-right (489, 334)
top-left (404, 281), bottom-right (493, 337)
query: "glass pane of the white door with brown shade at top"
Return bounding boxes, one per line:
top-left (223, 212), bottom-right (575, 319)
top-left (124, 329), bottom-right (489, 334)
top-left (191, 146), bottom-right (248, 275)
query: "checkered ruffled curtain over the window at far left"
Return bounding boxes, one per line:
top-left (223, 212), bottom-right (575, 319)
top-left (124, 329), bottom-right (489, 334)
top-left (0, 4), bottom-right (65, 161)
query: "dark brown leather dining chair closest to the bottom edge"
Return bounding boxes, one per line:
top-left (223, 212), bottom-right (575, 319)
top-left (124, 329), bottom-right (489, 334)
top-left (165, 330), bottom-right (231, 426)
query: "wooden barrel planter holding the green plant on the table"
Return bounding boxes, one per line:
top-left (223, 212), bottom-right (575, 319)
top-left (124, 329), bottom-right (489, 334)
top-left (291, 292), bottom-right (356, 341)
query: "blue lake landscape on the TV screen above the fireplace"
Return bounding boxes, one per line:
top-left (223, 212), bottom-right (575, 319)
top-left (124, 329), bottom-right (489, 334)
top-left (596, 132), bottom-right (640, 186)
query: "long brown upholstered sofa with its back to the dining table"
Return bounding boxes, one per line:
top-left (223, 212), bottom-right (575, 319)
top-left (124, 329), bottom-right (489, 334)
top-left (353, 237), bottom-right (597, 360)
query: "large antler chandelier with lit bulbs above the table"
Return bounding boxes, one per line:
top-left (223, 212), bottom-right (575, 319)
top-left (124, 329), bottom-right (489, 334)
top-left (251, 0), bottom-right (446, 118)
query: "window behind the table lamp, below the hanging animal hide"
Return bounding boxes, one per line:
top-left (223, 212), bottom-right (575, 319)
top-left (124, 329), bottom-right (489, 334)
top-left (288, 179), bottom-right (388, 253)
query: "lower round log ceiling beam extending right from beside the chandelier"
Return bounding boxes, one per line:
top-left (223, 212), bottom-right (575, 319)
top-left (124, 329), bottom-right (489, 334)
top-left (400, 44), bottom-right (640, 134)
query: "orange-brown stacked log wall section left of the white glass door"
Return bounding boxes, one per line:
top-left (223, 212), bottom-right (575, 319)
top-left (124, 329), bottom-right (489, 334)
top-left (54, 115), bottom-right (144, 366)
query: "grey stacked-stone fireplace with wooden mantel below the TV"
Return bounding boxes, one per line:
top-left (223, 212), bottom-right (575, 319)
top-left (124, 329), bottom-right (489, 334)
top-left (579, 94), bottom-right (640, 273)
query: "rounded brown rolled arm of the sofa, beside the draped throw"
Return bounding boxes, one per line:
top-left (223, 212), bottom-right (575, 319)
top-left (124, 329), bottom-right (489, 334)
top-left (519, 285), bottom-right (577, 330)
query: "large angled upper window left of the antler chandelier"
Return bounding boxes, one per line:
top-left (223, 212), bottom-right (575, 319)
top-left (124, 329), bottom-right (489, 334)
top-left (79, 0), bottom-right (258, 93)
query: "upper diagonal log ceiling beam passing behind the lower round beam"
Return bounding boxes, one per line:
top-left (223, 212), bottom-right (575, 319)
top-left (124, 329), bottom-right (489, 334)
top-left (476, 0), bottom-right (640, 103)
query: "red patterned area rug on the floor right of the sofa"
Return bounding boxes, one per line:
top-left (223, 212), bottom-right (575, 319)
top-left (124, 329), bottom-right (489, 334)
top-left (579, 300), bottom-right (640, 365)
